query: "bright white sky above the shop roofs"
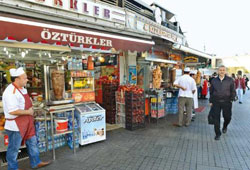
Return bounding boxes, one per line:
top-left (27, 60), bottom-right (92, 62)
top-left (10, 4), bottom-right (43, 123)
top-left (142, 0), bottom-right (250, 57)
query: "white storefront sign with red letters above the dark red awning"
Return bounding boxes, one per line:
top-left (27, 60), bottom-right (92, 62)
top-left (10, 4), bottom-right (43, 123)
top-left (25, 0), bottom-right (125, 25)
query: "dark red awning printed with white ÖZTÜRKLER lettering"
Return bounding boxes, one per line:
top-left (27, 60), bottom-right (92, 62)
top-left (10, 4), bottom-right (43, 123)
top-left (0, 16), bottom-right (154, 52)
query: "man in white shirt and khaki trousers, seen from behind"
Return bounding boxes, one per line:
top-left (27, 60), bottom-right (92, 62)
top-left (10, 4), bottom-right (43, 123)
top-left (174, 67), bottom-right (197, 127)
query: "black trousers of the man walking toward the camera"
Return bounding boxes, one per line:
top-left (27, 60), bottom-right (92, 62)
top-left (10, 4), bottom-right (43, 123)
top-left (212, 101), bottom-right (232, 136)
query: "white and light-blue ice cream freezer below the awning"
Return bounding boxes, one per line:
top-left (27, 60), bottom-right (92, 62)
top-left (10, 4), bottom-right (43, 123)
top-left (75, 102), bottom-right (106, 145)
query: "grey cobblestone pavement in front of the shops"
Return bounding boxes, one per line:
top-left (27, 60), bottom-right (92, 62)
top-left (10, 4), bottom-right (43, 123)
top-left (3, 92), bottom-right (250, 170)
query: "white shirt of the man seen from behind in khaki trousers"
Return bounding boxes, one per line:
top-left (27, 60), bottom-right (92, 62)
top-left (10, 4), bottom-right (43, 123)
top-left (174, 74), bottom-right (197, 98)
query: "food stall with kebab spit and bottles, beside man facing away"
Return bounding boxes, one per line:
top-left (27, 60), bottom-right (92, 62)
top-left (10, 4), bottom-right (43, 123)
top-left (137, 51), bottom-right (183, 122)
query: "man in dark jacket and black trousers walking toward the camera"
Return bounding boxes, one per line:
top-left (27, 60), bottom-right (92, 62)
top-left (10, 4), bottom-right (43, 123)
top-left (209, 66), bottom-right (236, 140)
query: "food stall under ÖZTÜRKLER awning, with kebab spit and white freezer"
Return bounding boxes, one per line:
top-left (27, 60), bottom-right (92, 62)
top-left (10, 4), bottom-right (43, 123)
top-left (0, 47), bottom-right (117, 159)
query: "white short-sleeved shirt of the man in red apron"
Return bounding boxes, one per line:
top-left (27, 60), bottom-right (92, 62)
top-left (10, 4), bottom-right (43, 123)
top-left (2, 84), bottom-right (27, 131)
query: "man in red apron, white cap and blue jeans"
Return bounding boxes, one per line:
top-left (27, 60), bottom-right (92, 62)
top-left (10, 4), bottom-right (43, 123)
top-left (3, 67), bottom-right (50, 170)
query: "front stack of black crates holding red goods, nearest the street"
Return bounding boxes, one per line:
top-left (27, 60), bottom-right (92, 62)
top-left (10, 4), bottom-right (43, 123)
top-left (125, 92), bottom-right (145, 130)
